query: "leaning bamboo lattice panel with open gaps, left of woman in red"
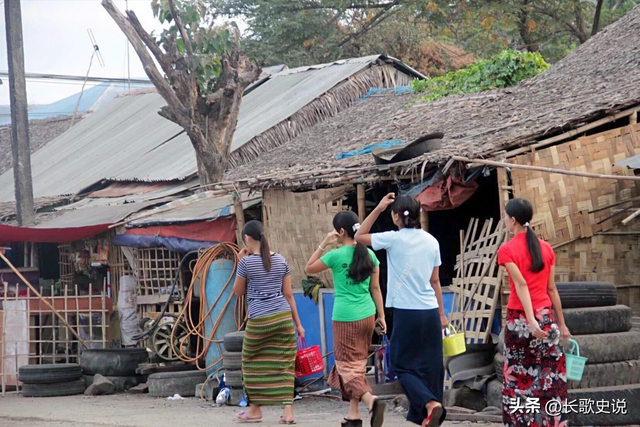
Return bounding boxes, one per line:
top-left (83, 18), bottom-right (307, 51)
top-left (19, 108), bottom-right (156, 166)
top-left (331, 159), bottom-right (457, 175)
top-left (449, 218), bottom-right (505, 343)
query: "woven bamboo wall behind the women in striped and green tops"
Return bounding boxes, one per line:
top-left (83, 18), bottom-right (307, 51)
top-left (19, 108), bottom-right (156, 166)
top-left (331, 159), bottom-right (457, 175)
top-left (262, 187), bottom-right (350, 288)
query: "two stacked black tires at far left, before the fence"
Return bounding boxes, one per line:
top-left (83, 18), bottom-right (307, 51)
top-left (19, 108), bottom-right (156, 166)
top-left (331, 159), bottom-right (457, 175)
top-left (18, 363), bottom-right (85, 397)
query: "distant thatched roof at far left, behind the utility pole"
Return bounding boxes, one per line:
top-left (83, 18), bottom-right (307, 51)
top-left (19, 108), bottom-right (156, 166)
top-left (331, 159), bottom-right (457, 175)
top-left (0, 116), bottom-right (81, 175)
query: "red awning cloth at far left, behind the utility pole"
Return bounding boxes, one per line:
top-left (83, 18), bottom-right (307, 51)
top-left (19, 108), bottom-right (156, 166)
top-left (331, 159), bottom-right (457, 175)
top-left (0, 224), bottom-right (111, 244)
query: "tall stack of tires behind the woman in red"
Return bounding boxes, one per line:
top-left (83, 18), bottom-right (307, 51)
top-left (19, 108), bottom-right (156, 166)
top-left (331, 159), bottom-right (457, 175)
top-left (487, 282), bottom-right (640, 426)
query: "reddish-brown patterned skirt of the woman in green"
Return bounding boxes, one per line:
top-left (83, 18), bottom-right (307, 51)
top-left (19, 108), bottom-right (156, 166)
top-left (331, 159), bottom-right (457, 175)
top-left (327, 315), bottom-right (376, 402)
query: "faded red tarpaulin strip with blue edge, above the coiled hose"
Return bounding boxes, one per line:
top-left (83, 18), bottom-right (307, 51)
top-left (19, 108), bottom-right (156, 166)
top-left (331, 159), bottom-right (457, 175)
top-left (124, 217), bottom-right (236, 246)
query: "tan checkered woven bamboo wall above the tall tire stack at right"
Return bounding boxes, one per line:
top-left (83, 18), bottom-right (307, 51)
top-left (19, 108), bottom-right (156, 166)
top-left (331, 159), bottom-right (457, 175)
top-left (511, 124), bottom-right (640, 313)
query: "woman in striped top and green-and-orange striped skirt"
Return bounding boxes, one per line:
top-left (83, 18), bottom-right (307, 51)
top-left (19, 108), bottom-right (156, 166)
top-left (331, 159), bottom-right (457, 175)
top-left (233, 221), bottom-right (304, 424)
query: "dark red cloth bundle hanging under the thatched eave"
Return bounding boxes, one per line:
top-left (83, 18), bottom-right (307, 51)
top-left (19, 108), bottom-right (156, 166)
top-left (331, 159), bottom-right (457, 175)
top-left (416, 175), bottom-right (478, 211)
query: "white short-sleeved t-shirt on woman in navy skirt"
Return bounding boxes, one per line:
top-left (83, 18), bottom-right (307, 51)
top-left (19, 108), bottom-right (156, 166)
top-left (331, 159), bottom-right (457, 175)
top-left (371, 228), bottom-right (442, 310)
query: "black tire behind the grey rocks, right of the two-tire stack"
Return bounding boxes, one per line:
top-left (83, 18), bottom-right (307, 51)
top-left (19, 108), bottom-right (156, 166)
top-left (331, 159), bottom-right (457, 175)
top-left (80, 348), bottom-right (149, 377)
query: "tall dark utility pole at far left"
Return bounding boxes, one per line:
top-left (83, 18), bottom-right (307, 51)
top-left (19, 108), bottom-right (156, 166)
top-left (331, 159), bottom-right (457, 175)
top-left (4, 0), bottom-right (35, 226)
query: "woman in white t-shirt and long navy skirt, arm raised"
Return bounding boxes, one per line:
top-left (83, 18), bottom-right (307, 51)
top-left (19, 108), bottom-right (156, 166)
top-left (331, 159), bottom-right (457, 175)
top-left (355, 193), bottom-right (449, 427)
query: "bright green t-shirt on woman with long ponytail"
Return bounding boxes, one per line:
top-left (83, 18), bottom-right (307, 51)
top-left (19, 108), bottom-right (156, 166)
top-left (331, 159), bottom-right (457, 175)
top-left (320, 246), bottom-right (380, 322)
